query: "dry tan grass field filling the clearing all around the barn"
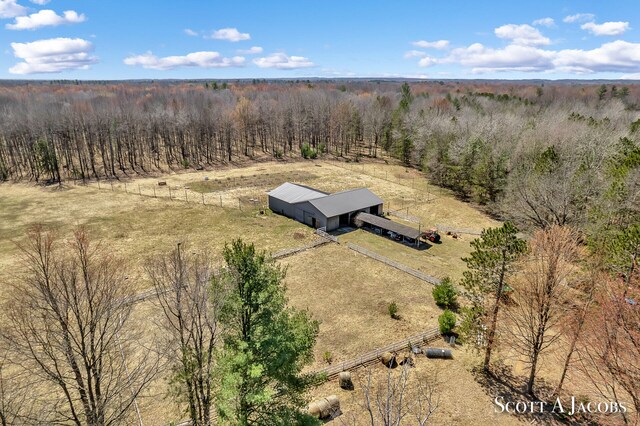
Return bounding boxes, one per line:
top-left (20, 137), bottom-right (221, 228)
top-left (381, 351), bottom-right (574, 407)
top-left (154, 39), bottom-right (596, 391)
top-left (0, 161), bottom-right (528, 424)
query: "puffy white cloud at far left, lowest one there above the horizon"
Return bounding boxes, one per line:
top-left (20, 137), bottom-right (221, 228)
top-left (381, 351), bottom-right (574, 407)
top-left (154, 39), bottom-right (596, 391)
top-left (9, 38), bottom-right (98, 74)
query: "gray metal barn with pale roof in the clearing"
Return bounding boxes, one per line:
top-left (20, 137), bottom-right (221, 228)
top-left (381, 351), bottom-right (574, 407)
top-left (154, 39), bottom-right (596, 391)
top-left (268, 182), bottom-right (383, 231)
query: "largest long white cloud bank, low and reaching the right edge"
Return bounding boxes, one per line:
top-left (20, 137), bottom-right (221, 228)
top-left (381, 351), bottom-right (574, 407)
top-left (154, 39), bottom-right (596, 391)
top-left (418, 40), bottom-right (640, 74)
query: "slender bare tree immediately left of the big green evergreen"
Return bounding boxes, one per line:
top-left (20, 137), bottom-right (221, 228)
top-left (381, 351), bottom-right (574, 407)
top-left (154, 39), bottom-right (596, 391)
top-left (146, 243), bottom-right (224, 426)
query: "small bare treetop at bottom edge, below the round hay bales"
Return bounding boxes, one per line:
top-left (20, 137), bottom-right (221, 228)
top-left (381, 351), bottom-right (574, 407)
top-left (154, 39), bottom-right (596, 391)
top-left (360, 364), bottom-right (439, 426)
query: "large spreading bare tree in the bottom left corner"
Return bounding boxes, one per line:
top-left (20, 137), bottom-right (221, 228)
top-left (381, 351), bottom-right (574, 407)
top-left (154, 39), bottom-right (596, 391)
top-left (4, 226), bottom-right (158, 426)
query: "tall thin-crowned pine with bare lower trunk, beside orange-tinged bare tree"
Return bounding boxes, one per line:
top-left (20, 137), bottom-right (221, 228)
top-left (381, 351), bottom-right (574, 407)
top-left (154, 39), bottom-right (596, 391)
top-left (462, 222), bottom-right (527, 370)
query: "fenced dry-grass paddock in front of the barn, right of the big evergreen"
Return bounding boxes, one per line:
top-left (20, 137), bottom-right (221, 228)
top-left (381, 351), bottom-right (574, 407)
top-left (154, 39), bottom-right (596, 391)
top-left (282, 244), bottom-right (441, 368)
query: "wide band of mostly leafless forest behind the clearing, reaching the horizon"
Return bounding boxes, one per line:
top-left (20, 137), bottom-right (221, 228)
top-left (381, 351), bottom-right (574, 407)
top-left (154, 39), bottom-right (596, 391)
top-left (0, 81), bottom-right (640, 235)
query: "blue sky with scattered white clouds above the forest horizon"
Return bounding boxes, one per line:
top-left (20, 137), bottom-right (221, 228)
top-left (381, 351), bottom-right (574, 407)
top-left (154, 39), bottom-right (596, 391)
top-left (0, 0), bottom-right (640, 80)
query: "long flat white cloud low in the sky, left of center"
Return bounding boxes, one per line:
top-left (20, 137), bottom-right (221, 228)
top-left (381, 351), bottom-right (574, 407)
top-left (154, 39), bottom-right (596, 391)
top-left (124, 52), bottom-right (245, 71)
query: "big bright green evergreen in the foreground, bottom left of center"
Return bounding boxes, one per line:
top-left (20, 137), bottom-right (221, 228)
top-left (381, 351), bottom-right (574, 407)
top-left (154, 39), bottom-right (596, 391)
top-left (216, 240), bottom-right (318, 426)
